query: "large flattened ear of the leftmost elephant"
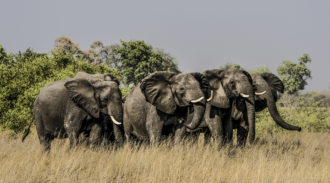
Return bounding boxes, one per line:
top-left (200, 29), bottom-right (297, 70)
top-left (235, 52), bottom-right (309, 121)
top-left (64, 79), bottom-right (100, 118)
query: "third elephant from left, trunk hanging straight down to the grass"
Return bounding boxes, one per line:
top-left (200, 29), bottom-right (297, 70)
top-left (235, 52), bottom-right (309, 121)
top-left (179, 69), bottom-right (255, 147)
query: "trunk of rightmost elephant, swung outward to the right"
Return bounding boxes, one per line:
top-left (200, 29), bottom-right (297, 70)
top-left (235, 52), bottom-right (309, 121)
top-left (266, 96), bottom-right (301, 131)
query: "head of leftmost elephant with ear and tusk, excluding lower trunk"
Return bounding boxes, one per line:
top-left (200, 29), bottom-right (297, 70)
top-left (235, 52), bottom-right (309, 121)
top-left (64, 73), bottom-right (123, 125)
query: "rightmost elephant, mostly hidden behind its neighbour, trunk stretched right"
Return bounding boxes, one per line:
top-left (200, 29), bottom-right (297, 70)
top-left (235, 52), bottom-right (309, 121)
top-left (232, 73), bottom-right (301, 146)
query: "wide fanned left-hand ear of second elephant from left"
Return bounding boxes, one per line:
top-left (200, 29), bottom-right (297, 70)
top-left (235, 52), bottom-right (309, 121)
top-left (140, 71), bottom-right (177, 114)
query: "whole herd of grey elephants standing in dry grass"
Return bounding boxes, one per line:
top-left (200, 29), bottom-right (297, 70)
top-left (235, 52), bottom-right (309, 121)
top-left (22, 69), bottom-right (301, 150)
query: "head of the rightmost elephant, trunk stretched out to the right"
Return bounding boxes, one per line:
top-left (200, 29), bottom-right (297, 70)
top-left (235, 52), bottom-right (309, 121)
top-left (252, 73), bottom-right (301, 131)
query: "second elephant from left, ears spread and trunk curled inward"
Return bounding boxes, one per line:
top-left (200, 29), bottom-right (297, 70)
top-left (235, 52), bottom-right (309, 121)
top-left (124, 71), bottom-right (205, 144)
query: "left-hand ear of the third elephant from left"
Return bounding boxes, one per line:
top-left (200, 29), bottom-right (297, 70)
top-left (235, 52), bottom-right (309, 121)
top-left (203, 69), bottom-right (231, 108)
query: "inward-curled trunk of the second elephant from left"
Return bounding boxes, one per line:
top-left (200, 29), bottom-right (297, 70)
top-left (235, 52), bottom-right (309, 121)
top-left (183, 103), bottom-right (205, 130)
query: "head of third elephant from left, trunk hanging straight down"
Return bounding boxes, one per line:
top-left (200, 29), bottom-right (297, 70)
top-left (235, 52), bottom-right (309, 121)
top-left (203, 69), bottom-right (255, 142)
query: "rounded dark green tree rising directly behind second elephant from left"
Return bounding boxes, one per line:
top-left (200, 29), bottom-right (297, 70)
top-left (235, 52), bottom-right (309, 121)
top-left (113, 41), bottom-right (178, 85)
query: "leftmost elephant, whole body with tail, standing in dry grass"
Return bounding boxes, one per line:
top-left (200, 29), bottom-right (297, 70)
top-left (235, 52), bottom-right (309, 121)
top-left (22, 72), bottom-right (123, 150)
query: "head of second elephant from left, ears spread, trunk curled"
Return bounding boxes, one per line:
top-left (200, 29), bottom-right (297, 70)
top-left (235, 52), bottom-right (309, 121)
top-left (140, 71), bottom-right (208, 129)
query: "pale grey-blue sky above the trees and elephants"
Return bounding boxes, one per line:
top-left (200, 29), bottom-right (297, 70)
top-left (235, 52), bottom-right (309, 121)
top-left (0, 0), bottom-right (330, 91)
